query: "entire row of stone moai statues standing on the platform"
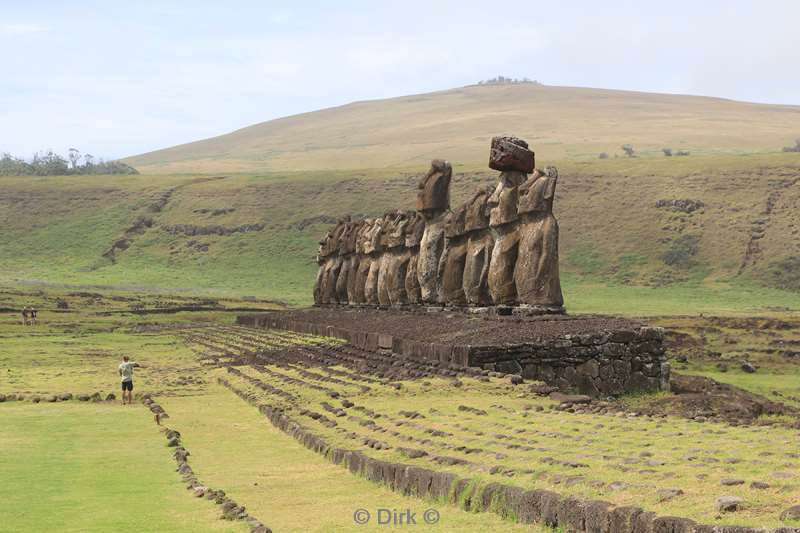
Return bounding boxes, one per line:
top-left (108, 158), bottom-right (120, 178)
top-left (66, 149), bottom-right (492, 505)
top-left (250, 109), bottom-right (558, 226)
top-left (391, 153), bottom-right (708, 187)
top-left (314, 137), bottom-right (564, 313)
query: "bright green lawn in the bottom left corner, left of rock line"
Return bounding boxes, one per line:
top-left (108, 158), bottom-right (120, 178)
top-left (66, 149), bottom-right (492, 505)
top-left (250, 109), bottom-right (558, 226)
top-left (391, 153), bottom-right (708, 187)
top-left (0, 401), bottom-right (247, 533)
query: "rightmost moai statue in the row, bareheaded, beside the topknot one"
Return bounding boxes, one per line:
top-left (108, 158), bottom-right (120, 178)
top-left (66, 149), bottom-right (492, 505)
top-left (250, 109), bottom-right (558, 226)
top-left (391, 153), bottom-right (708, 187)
top-left (514, 167), bottom-right (564, 312)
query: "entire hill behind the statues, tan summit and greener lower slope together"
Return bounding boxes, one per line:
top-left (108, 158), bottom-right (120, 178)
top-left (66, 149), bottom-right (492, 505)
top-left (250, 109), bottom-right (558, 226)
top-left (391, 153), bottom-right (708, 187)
top-left (0, 85), bottom-right (800, 314)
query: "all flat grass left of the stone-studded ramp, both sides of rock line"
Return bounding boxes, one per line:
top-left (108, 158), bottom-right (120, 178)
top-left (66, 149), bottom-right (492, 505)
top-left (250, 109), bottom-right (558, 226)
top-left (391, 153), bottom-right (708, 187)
top-left (0, 290), bottom-right (544, 532)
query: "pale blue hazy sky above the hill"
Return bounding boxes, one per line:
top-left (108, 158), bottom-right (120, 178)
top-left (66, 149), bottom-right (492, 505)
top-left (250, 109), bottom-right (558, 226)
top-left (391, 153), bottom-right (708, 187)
top-left (0, 0), bottom-right (800, 159)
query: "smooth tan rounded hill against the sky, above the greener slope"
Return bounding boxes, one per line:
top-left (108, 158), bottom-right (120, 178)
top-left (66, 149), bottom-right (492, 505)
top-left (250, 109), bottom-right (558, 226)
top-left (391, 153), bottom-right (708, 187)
top-left (124, 84), bottom-right (800, 173)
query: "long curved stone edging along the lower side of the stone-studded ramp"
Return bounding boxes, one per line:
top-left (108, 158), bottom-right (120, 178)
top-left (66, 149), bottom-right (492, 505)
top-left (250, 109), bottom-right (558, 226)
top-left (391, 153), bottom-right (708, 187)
top-left (218, 377), bottom-right (800, 533)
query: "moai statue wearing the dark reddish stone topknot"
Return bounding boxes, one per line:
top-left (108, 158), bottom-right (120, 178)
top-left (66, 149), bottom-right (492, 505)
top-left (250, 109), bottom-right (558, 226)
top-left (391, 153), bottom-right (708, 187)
top-left (487, 137), bottom-right (534, 305)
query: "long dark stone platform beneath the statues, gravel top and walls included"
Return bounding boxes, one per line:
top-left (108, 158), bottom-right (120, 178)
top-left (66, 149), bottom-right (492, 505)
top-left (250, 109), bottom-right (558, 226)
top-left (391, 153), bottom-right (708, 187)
top-left (237, 307), bottom-right (669, 396)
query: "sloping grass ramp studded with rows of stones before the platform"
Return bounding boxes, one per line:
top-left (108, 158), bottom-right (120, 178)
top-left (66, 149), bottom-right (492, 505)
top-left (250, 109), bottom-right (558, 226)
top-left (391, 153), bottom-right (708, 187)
top-left (204, 328), bottom-right (800, 526)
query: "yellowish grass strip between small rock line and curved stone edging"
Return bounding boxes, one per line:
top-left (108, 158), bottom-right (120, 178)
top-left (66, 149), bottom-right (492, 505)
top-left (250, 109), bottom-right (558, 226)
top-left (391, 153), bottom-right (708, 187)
top-left (162, 386), bottom-right (551, 533)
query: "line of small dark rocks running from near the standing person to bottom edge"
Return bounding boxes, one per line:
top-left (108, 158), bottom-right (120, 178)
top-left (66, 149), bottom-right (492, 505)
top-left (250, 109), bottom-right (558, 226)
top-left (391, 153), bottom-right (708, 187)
top-left (142, 394), bottom-right (272, 533)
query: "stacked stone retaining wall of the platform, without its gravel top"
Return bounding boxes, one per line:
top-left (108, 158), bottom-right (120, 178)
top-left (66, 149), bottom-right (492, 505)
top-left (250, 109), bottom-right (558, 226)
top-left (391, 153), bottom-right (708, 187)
top-left (237, 311), bottom-right (670, 397)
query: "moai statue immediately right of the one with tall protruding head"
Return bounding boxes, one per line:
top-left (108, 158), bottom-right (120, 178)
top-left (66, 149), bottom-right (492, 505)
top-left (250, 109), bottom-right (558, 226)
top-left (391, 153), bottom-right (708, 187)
top-left (438, 204), bottom-right (467, 305)
